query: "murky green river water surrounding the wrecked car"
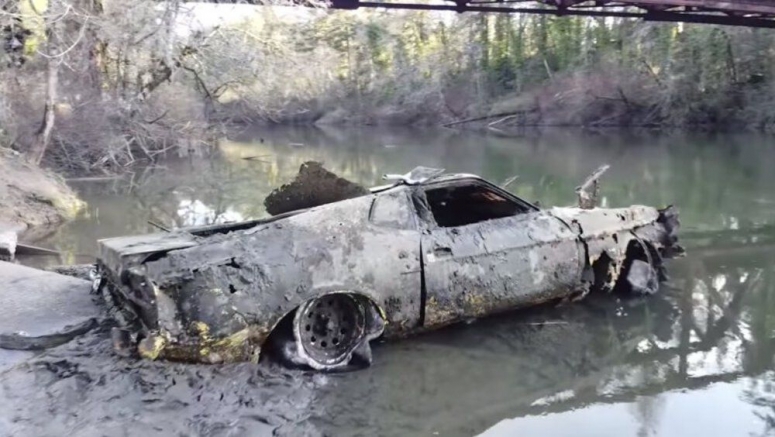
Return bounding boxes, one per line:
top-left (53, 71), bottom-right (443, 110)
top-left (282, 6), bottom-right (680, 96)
top-left (12, 129), bottom-right (775, 437)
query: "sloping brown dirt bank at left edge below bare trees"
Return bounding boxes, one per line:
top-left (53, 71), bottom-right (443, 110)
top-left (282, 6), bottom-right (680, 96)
top-left (0, 148), bottom-right (82, 240)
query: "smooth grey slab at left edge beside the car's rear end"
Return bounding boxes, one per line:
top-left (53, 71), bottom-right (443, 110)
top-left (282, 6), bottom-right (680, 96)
top-left (0, 261), bottom-right (101, 350)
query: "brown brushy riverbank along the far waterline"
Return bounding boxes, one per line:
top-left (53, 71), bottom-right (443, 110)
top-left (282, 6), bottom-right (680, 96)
top-left (258, 64), bottom-right (775, 133)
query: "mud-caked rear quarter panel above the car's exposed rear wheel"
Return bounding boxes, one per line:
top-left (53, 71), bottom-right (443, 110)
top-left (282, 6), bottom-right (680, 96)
top-left (136, 195), bottom-right (421, 360)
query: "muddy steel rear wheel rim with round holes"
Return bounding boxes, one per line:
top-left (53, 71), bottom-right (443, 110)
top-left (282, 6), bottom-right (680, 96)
top-left (295, 293), bottom-right (365, 368)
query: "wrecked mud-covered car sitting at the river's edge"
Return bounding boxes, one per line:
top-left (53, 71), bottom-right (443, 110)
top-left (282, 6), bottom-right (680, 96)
top-left (98, 164), bottom-right (681, 369)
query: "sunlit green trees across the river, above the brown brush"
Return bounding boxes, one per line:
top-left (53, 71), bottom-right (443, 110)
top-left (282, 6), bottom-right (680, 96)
top-left (229, 10), bottom-right (775, 125)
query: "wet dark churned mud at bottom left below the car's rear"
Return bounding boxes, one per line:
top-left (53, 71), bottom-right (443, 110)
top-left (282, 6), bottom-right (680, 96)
top-left (0, 326), bottom-right (326, 437)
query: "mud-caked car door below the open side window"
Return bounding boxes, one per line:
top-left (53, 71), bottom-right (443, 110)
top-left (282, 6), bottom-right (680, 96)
top-left (421, 180), bottom-right (584, 327)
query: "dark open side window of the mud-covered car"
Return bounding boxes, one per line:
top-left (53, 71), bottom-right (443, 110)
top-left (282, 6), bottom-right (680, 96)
top-left (425, 184), bottom-right (530, 228)
